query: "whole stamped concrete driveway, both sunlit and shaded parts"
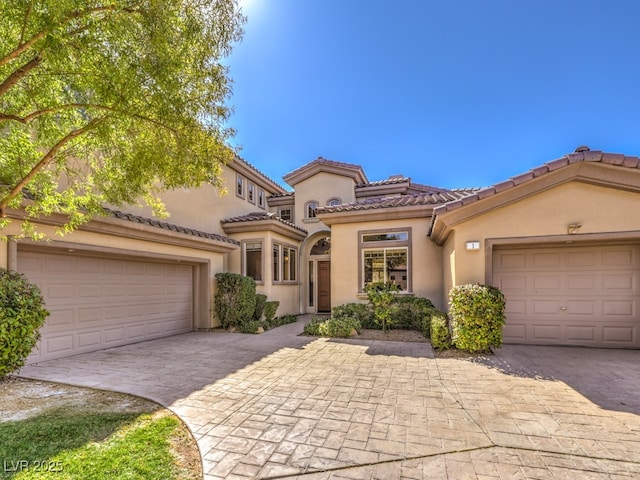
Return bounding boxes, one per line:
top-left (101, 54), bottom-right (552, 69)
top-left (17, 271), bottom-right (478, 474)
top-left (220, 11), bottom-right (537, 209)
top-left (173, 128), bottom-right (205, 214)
top-left (21, 321), bottom-right (640, 480)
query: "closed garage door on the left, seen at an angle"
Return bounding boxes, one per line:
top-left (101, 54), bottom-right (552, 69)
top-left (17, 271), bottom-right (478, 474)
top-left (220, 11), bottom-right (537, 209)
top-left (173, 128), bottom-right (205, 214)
top-left (18, 251), bottom-right (193, 363)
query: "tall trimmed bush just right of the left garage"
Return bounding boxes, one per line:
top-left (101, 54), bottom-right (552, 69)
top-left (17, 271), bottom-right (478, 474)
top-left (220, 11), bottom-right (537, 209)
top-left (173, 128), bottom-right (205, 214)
top-left (214, 273), bottom-right (256, 328)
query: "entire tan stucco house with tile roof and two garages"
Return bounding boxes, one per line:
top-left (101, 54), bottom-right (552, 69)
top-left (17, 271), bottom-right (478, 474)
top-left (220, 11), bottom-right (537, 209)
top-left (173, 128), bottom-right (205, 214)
top-left (0, 147), bottom-right (640, 362)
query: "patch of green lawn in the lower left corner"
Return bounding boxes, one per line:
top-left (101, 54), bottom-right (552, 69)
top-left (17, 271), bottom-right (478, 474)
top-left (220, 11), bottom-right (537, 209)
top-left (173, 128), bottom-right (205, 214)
top-left (0, 407), bottom-right (198, 480)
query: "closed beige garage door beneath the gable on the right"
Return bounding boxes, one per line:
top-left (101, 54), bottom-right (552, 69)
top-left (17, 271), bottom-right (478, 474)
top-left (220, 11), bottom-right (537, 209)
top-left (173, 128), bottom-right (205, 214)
top-left (493, 245), bottom-right (640, 348)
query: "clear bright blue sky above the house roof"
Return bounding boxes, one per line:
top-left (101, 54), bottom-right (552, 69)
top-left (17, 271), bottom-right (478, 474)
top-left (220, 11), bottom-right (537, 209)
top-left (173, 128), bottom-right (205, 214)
top-left (225, 0), bottom-right (640, 188)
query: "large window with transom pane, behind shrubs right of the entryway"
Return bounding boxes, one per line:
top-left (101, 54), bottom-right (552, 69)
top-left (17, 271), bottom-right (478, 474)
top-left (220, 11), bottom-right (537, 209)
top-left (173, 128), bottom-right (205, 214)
top-left (360, 229), bottom-right (411, 292)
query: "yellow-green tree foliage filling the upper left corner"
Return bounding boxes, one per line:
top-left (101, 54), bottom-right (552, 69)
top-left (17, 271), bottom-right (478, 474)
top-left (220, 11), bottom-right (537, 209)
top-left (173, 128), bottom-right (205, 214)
top-left (0, 0), bottom-right (244, 236)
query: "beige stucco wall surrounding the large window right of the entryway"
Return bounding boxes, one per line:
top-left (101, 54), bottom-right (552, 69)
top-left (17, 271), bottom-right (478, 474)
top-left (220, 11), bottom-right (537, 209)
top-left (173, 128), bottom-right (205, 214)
top-left (331, 217), bottom-right (443, 308)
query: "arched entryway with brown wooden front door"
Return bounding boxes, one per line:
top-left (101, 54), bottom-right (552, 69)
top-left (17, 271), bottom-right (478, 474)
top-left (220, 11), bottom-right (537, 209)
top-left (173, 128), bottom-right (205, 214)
top-left (302, 231), bottom-right (331, 313)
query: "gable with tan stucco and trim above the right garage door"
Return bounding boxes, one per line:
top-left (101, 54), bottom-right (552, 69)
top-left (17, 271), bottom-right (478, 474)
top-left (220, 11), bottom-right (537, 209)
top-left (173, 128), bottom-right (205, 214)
top-left (430, 162), bottom-right (640, 245)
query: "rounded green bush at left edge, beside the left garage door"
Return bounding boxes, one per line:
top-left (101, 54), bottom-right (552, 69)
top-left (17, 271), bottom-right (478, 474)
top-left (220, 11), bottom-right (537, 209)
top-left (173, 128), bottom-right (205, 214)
top-left (0, 268), bottom-right (49, 378)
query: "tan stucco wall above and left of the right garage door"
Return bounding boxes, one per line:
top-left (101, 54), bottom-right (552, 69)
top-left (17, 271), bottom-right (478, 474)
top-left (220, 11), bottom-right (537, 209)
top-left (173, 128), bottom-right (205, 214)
top-left (445, 181), bottom-right (640, 285)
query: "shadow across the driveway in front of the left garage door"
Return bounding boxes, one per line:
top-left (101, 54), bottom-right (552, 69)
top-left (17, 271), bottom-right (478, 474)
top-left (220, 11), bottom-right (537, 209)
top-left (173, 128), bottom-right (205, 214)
top-left (19, 320), bottom-right (316, 405)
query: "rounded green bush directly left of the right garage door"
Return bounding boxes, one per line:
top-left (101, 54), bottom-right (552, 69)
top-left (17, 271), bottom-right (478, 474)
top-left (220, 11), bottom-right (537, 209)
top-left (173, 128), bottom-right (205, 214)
top-left (449, 285), bottom-right (505, 353)
